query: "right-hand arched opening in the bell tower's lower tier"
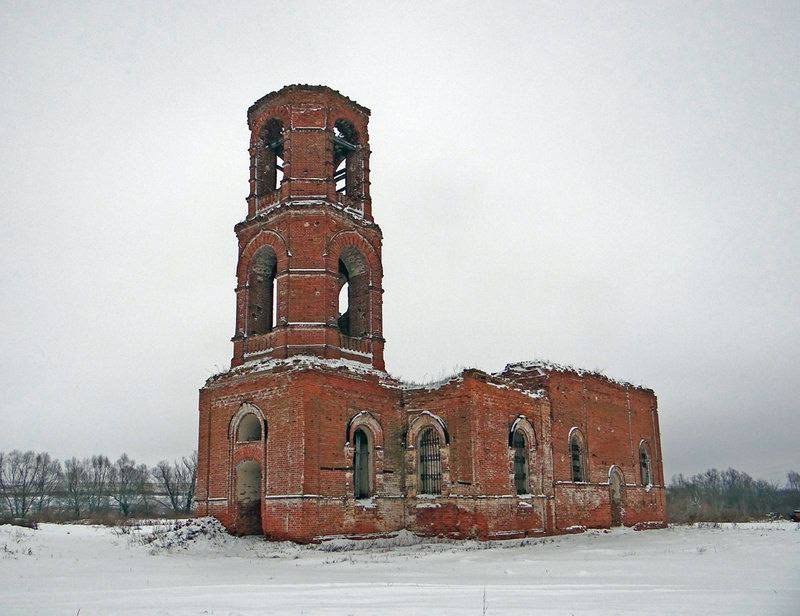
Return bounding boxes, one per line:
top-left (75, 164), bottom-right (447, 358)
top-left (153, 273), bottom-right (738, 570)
top-left (338, 246), bottom-right (370, 337)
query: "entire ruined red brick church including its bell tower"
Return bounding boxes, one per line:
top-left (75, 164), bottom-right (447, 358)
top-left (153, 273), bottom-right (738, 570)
top-left (197, 85), bottom-right (665, 542)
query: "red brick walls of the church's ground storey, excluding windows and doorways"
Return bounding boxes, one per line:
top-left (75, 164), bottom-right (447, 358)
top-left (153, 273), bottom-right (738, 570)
top-left (198, 367), bottom-right (664, 541)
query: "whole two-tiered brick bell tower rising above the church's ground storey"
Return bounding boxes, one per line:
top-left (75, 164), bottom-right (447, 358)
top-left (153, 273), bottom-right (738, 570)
top-left (231, 85), bottom-right (384, 370)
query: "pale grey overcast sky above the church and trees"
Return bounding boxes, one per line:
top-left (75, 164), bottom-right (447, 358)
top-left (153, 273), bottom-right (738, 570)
top-left (0, 0), bottom-right (800, 482)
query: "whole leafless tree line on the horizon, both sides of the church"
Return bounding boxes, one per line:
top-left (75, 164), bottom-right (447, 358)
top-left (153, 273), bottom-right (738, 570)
top-left (0, 449), bottom-right (800, 524)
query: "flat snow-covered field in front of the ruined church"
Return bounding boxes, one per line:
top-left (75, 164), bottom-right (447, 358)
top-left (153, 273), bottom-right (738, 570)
top-left (0, 521), bottom-right (800, 616)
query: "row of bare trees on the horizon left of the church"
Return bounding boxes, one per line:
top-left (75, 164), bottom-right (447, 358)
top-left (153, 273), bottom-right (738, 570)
top-left (0, 449), bottom-right (197, 522)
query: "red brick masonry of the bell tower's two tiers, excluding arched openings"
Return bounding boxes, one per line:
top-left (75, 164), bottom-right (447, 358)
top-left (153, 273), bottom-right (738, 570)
top-left (231, 86), bottom-right (383, 369)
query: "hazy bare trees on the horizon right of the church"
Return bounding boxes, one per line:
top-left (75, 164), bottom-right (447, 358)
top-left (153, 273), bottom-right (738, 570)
top-left (667, 468), bottom-right (800, 524)
